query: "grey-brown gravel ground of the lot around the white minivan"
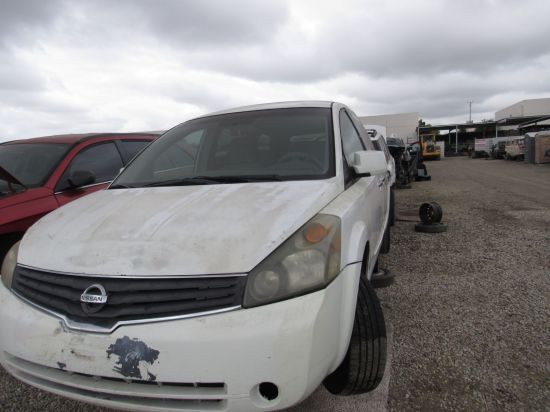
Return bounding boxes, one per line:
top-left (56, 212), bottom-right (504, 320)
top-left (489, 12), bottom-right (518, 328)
top-left (0, 158), bottom-right (550, 412)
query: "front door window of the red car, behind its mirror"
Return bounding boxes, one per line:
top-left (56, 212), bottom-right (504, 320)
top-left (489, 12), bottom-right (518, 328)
top-left (56, 142), bottom-right (123, 191)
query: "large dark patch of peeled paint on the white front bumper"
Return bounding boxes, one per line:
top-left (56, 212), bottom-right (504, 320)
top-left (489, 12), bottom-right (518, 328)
top-left (107, 336), bottom-right (160, 381)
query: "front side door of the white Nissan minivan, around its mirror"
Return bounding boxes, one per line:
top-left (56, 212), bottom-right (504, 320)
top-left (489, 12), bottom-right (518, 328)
top-left (339, 109), bottom-right (389, 250)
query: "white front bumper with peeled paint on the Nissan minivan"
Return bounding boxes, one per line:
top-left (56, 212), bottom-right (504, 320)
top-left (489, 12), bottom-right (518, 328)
top-left (0, 264), bottom-right (360, 411)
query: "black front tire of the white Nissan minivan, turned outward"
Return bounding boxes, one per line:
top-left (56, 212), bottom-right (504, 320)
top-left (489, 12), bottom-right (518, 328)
top-left (323, 276), bottom-right (386, 395)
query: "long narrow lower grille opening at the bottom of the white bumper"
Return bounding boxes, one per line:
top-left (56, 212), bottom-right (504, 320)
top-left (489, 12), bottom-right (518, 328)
top-left (4, 352), bottom-right (229, 411)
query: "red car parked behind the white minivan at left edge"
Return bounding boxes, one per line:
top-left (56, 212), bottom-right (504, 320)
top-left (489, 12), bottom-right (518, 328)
top-left (0, 132), bottom-right (160, 263)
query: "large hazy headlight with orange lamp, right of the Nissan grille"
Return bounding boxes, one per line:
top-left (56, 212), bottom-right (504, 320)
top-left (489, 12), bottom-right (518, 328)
top-left (243, 214), bottom-right (340, 308)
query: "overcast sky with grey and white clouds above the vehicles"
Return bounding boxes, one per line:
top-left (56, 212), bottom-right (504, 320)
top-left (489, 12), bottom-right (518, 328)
top-left (0, 0), bottom-right (550, 141)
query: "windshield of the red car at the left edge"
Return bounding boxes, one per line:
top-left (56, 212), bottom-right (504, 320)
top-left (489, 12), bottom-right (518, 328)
top-left (0, 143), bottom-right (70, 193)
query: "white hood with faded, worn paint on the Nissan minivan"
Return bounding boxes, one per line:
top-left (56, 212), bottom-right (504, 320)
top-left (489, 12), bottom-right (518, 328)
top-left (18, 178), bottom-right (339, 276)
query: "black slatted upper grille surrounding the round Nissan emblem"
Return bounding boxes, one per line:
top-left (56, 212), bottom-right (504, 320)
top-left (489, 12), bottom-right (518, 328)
top-left (12, 266), bottom-right (246, 328)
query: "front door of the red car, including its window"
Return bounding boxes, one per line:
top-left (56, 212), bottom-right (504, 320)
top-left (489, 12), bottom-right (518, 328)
top-left (55, 141), bottom-right (123, 206)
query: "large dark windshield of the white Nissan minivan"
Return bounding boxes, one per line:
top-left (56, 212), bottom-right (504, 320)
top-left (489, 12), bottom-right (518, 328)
top-left (111, 108), bottom-right (335, 188)
